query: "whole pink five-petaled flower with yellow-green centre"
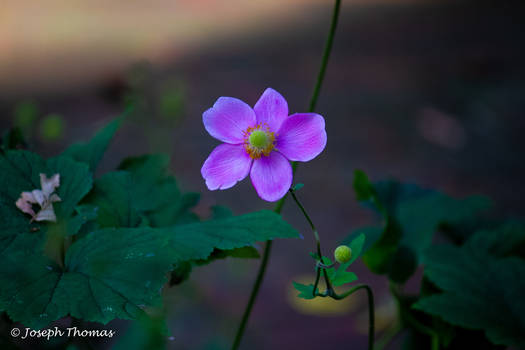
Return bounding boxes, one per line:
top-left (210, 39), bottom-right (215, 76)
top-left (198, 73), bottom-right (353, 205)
top-left (201, 88), bottom-right (326, 202)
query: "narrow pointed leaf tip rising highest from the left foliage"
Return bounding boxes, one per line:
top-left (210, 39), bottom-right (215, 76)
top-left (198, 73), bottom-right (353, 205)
top-left (62, 116), bottom-right (124, 172)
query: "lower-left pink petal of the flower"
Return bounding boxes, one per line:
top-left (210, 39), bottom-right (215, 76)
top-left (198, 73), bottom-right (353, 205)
top-left (201, 143), bottom-right (252, 191)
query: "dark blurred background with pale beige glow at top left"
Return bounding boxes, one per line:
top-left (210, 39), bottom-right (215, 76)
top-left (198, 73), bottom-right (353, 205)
top-left (0, 0), bottom-right (525, 350)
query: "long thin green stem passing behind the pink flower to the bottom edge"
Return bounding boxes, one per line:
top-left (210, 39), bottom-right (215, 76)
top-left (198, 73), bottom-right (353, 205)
top-left (232, 0), bottom-right (341, 350)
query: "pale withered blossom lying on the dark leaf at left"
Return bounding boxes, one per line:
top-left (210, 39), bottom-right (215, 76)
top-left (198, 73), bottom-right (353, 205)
top-left (16, 174), bottom-right (61, 222)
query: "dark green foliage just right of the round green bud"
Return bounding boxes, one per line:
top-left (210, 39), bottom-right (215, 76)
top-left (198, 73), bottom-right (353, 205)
top-left (350, 170), bottom-right (490, 283)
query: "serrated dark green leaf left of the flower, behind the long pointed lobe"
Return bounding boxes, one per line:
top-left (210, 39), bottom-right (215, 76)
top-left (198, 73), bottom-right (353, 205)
top-left (85, 154), bottom-right (199, 227)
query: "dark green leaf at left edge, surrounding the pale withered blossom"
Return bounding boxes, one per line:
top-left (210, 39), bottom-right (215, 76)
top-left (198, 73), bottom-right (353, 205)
top-left (0, 150), bottom-right (92, 252)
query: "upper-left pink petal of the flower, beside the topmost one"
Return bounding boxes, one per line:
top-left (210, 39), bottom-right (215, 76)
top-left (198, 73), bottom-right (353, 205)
top-left (202, 97), bottom-right (256, 144)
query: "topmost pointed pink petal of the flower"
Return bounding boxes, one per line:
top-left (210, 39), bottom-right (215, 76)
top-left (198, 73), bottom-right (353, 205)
top-left (253, 88), bottom-right (288, 131)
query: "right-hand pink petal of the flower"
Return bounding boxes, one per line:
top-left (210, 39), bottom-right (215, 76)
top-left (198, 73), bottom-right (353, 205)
top-left (276, 113), bottom-right (326, 162)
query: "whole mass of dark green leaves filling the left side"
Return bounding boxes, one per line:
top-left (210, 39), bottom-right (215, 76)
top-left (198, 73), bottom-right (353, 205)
top-left (0, 119), bottom-right (299, 329)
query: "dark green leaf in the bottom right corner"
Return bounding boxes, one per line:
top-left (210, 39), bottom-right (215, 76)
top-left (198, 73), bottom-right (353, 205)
top-left (414, 244), bottom-right (525, 348)
